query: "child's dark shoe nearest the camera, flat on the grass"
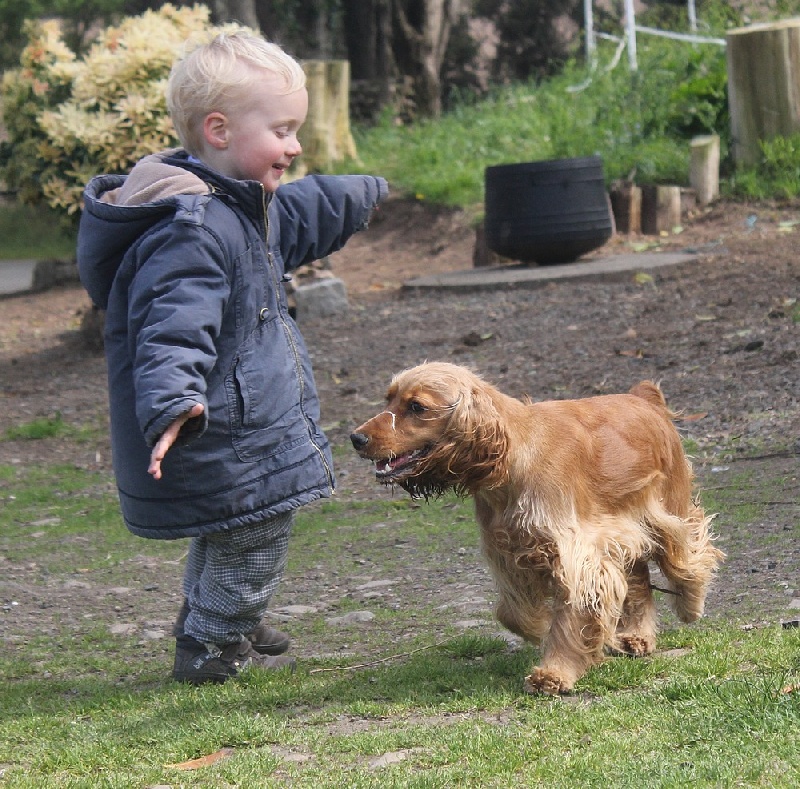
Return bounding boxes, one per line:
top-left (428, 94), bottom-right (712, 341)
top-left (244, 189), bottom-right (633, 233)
top-left (172, 635), bottom-right (296, 685)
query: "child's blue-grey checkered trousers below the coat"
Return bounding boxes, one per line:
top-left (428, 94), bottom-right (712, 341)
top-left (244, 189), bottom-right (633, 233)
top-left (183, 512), bottom-right (294, 645)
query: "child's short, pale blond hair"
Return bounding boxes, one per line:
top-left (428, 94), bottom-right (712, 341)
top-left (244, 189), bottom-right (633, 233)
top-left (167, 28), bottom-right (306, 155)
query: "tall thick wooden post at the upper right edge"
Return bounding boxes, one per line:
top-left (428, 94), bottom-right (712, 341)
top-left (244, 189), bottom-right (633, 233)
top-left (726, 18), bottom-right (800, 167)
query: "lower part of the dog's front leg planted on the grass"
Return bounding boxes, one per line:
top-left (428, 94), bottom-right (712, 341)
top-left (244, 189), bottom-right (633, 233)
top-left (524, 600), bottom-right (604, 696)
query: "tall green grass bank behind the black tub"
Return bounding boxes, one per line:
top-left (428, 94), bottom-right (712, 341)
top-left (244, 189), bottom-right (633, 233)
top-left (334, 37), bottom-right (727, 207)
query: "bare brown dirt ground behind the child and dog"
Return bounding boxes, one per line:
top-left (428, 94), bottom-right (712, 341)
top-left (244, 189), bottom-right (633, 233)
top-left (0, 199), bottom-right (800, 640)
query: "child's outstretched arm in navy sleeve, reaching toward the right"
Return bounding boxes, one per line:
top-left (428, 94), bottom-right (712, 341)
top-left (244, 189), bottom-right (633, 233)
top-left (273, 175), bottom-right (389, 271)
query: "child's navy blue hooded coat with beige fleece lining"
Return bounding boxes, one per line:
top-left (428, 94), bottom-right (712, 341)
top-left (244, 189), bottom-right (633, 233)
top-left (78, 151), bottom-right (387, 539)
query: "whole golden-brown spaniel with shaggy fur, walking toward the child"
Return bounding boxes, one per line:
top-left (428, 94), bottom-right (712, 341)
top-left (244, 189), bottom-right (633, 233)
top-left (350, 363), bottom-right (723, 694)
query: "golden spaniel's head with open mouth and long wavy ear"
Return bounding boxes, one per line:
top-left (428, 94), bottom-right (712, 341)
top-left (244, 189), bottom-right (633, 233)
top-left (350, 362), bottom-right (507, 498)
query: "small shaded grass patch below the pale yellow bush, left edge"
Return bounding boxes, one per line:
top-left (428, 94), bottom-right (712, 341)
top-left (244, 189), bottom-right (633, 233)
top-left (0, 203), bottom-right (75, 260)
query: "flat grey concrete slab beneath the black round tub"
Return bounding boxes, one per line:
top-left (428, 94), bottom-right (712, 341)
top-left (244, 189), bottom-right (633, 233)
top-left (403, 252), bottom-right (697, 291)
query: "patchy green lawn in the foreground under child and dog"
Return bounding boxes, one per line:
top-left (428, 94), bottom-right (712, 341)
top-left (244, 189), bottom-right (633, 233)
top-left (0, 458), bottom-right (800, 789)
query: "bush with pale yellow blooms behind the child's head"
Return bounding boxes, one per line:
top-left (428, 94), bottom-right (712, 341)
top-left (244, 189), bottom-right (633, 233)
top-left (0, 5), bottom-right (216, 222)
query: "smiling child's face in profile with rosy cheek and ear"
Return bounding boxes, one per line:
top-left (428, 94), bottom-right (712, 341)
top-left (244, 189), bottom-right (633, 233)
top-left (203, 79), bottom-right (308, 192)
